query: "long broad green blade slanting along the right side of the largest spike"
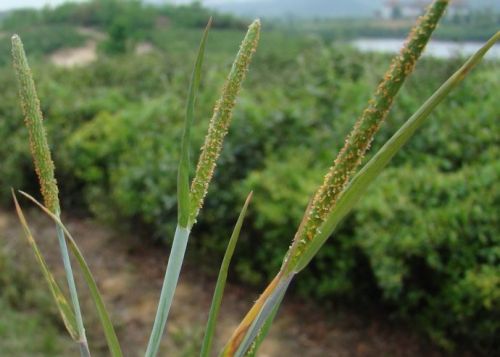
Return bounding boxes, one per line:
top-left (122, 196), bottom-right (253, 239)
top-left (294, 31), bottom-right (500, 272)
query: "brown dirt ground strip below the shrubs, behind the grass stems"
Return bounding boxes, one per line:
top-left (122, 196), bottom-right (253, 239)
top-left (0, 211), bottom-right (440, 357)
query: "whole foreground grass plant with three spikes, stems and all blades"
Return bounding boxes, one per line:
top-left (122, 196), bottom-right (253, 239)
top-left (8, 0), bottom-right (500, 357)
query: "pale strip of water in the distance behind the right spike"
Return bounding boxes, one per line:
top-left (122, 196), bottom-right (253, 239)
top-left (351, 38), bottom-right (500, 60)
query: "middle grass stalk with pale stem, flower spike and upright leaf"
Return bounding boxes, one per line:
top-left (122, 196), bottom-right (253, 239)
top-left (146, 20), bottom-right (260, 357)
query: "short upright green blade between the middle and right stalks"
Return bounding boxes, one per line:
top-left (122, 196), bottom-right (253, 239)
top-left (200, 192), bottom-right (252, 357)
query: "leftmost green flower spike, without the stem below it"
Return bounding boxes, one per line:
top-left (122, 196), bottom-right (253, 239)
top-left (12, 35), bottom-right (60, 214)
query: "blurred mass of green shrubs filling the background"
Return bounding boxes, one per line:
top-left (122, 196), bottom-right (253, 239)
top-left (0, 1), bottom-right (500, 355)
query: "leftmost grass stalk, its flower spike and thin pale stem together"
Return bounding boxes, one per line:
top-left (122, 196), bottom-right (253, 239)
top-left (12, 35), bottom-right (90, 356)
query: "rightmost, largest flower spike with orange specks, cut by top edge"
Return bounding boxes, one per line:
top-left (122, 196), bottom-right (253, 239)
top-left (292, 0), bottom-right (449, 259)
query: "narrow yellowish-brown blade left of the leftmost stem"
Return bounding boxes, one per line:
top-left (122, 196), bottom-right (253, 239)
top-left (12, 192), bottom-right (79, 342)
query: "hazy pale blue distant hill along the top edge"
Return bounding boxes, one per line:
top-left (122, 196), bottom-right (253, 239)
top-left (206, 0), bottom-right (500, 18)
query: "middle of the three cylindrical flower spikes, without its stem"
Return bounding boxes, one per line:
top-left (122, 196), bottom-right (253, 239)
top-left (189, 20), bottom-right (260, 224)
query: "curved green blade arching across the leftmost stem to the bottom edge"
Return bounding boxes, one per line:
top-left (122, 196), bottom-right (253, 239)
top-left (19, 191), bottom-right (123, 357)
